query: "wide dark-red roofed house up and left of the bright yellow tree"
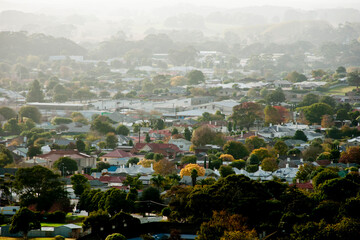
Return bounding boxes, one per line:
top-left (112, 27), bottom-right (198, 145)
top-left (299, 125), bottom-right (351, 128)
top-left (131, 143), bottom-right (182, 159)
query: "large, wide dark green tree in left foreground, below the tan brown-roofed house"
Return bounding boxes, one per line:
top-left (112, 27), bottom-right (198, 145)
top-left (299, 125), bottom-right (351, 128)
top-left (14, 165), bottom-right (70, 211)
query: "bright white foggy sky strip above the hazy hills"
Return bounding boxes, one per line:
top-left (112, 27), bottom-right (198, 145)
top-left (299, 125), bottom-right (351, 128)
top-left (0, 0), bottom-right (360, 16)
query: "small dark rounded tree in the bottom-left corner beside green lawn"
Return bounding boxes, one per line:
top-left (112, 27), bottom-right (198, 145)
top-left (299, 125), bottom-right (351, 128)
top-left (9, 207), bottom-right (41, 240)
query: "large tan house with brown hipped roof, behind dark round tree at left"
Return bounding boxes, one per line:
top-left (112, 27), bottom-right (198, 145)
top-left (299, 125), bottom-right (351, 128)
top-left (37, 149), bottom-right (96, 172)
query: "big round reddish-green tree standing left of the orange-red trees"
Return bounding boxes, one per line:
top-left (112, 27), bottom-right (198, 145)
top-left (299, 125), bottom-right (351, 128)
top-left (231, 102), bottom-right (263, 131)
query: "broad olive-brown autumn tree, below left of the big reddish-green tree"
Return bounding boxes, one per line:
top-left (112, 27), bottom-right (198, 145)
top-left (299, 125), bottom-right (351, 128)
top-left (191, 125), bottom-right (224, 147)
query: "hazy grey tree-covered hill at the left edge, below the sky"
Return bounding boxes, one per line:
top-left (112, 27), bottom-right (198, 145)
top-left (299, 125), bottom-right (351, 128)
top-left (0, 32), bottom-right (86, 61)
